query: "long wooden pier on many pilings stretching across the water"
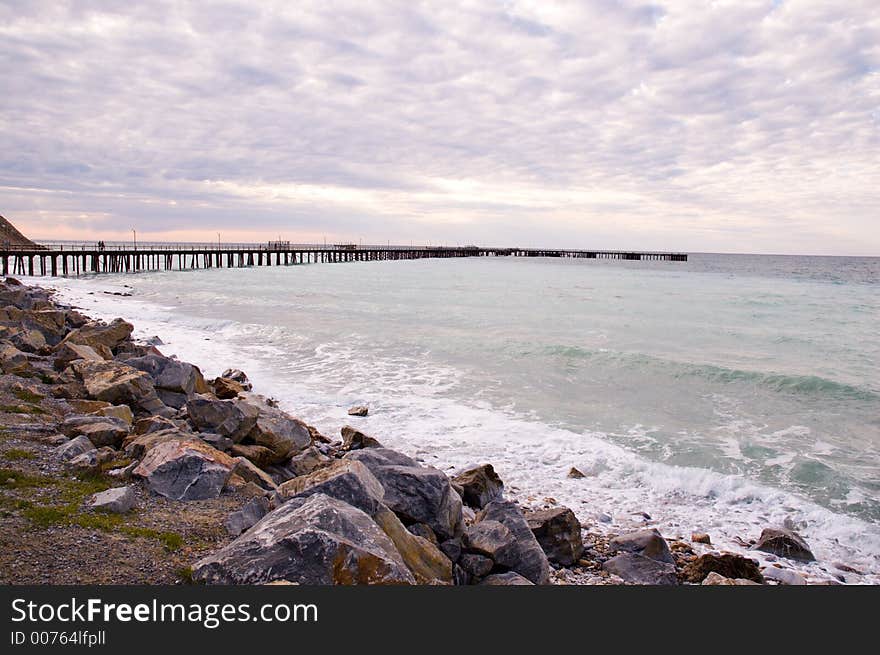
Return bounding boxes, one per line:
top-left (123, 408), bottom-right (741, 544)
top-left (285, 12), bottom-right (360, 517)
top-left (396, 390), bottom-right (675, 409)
top-left (0, 242), bottom-right (688, 277)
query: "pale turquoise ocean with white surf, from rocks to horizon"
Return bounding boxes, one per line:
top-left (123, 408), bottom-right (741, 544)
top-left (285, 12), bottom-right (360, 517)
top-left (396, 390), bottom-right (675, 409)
top-left (34, 254), bottom-right (880, 583)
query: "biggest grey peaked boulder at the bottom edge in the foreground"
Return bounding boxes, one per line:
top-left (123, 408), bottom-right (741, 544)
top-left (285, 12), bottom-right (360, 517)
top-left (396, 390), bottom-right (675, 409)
top-left (193, 494), bottom-right (415, 585)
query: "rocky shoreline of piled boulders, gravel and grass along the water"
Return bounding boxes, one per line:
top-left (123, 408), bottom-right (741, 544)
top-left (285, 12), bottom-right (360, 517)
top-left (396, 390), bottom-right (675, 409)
top-left (0, 278), bottom-right (859, 585)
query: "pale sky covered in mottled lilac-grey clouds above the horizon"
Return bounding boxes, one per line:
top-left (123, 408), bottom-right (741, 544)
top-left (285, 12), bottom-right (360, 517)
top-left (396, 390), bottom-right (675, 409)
top-left (0, 0), bottom-right (880, 255)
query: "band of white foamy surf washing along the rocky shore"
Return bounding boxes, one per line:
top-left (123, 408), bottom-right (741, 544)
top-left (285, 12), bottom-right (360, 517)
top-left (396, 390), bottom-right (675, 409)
top-left (39, 278), bottom-right (880, 584)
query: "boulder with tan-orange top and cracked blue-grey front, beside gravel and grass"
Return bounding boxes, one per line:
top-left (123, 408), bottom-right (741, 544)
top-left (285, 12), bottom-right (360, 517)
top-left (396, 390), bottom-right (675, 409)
top-left (132, 439), bottom-right (235, 500)
